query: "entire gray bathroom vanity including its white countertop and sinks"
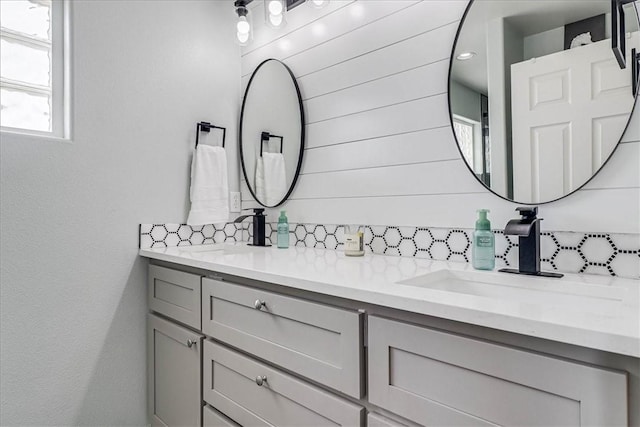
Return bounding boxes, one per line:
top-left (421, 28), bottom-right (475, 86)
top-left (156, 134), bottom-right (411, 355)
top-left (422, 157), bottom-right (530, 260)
top-left (140, 244), bottom-right (640, 426)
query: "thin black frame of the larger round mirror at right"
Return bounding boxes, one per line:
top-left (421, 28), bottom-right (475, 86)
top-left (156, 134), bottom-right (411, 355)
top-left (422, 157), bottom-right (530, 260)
top-left (447, 0), bottom-right (640, 206)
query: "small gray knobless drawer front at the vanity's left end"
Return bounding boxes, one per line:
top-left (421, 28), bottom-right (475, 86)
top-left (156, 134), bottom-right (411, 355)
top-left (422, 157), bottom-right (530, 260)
top-left (148, 265), bottom-right (202, 330)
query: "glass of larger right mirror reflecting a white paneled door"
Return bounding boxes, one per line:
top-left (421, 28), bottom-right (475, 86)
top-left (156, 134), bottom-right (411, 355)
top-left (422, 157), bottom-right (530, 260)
top-left (449, 0), bottom-right (640, 203)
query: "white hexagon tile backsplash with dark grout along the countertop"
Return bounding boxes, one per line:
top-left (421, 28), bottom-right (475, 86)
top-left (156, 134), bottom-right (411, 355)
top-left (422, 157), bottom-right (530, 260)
top-left (140, 223), bottom-right (640, 279)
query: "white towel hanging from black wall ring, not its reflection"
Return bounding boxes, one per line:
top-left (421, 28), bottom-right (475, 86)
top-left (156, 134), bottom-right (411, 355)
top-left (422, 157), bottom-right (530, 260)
top-left (187, 144), bottom-right (229, 225)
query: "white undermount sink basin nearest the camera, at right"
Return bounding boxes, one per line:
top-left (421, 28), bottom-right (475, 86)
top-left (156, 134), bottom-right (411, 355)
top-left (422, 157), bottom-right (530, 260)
top-left (398, 270), bottom-right (624, 308)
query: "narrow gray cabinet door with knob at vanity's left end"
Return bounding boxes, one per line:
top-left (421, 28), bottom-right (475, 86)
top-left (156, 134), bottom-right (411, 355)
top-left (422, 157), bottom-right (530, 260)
top-left (147, 314), bottom-right (203, 427)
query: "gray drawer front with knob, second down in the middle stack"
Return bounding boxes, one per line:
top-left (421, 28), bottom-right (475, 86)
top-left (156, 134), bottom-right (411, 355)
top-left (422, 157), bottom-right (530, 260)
top-left (203, 341), bottom-right (364, 426)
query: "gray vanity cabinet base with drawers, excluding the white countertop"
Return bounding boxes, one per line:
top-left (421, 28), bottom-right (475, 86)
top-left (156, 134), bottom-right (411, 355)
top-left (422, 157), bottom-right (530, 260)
top-left (148, 265), bottom-right (638, 427)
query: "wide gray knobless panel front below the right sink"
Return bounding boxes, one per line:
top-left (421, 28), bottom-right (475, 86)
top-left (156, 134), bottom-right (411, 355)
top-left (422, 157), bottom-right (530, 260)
top-left (368, 316), bottom-right (627, 426)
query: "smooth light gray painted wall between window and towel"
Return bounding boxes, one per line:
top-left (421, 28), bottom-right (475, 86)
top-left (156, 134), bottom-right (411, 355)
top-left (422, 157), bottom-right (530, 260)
top-left (0, 0), bottom-right (240, 426)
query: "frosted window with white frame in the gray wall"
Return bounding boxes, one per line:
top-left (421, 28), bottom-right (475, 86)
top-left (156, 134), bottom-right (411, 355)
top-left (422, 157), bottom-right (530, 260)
top-left (0, 0), bottom-right (68, 137)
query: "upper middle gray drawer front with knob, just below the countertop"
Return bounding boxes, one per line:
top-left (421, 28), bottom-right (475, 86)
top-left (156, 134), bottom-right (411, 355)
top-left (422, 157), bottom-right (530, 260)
top-left (202, 278), bottom-right (363, 398)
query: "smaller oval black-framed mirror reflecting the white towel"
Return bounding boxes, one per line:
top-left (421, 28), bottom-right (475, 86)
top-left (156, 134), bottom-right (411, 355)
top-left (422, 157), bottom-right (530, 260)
top-left (240, 59), bottom-right (304, 207)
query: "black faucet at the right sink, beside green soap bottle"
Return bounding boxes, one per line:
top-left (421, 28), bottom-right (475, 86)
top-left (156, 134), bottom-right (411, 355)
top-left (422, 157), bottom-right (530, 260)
top-left (499, 207), bottom-right (563, 277)
